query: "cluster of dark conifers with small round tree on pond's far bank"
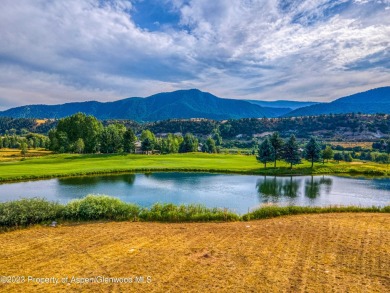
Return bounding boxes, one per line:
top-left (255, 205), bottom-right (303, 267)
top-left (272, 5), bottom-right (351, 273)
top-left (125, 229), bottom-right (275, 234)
top-left (256, 132), bottom-right (333, 168)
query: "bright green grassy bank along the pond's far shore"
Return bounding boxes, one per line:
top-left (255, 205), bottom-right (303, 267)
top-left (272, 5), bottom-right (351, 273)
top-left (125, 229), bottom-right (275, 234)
top-left (0, 153), bottom-right (390, 182)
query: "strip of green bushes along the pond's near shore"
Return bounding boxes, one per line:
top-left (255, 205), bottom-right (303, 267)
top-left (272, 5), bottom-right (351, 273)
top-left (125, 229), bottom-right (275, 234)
top-left (0, 195), bottom-right (390, 232)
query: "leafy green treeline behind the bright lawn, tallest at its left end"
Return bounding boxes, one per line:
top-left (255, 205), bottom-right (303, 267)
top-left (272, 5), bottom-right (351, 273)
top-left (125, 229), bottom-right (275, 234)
top-left (49, 113), bottom-right (222, 154)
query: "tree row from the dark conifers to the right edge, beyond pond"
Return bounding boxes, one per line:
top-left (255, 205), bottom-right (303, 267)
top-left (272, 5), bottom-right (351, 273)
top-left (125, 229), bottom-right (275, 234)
top-left (256, 132), bottom-right (390, 168)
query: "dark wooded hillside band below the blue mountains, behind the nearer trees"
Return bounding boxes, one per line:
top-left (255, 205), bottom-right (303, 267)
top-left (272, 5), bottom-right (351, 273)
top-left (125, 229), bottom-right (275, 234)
top-left (0, 114), bottom-right (390, 140)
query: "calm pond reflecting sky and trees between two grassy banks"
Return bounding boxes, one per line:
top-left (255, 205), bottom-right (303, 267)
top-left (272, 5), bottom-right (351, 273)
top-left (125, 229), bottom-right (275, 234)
top-left (0, 172), bottom-right (390, 214)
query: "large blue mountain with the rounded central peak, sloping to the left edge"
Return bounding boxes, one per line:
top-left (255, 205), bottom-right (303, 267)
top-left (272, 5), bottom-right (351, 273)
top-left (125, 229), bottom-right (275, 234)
top-left (0, 89), bottom-right (291, 121)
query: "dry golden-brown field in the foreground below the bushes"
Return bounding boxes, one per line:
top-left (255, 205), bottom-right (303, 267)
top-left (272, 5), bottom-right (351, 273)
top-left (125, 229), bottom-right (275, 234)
top-left (0, 213), bottom-right (390, 292)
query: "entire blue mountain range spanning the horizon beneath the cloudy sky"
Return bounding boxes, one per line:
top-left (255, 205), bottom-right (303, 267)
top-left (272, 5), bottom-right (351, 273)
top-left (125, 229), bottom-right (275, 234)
top-left (0, 87), bottom-right (390, 122)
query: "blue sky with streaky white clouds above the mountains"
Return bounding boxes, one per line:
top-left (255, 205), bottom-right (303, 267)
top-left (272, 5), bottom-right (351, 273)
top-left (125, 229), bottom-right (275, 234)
top-left (0, 0), bottom-right (390, 109)
